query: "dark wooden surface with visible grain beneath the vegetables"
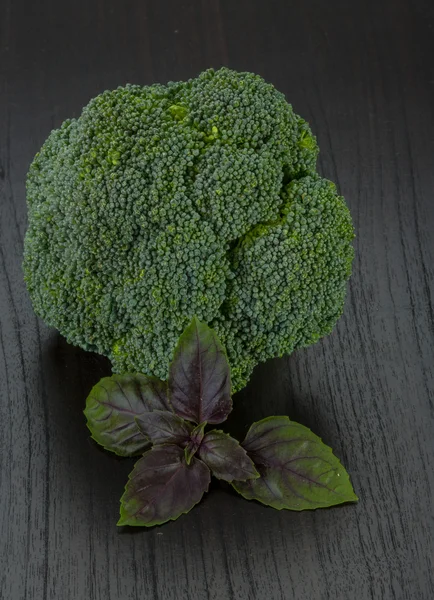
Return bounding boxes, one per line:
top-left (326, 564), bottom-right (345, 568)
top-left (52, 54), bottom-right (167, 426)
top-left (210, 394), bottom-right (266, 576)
top-left (0, 0), bottom-right (434, 600)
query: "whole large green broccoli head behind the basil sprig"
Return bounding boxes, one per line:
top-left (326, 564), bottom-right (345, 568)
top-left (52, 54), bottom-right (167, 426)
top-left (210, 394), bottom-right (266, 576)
top-left (23, 68), bottom-right (354, 391)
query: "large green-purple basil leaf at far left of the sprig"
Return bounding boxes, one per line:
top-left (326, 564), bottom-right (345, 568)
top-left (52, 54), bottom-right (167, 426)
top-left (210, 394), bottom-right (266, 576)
top-left (84, 374), bottom-right (170, 456)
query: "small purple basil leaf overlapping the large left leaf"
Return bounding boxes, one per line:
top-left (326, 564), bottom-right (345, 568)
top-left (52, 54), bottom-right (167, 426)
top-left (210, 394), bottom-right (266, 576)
top-left (136, 410), bottom-right (193, 446)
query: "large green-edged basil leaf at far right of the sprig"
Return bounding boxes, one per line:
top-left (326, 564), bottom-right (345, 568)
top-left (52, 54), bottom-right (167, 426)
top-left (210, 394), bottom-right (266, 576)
top-left (232, 417), bottom-right (358, 510)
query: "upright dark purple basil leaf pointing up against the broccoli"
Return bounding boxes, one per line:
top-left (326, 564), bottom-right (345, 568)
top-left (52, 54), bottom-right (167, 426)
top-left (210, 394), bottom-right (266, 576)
top-left (169, 317), bottom-right (232, 423)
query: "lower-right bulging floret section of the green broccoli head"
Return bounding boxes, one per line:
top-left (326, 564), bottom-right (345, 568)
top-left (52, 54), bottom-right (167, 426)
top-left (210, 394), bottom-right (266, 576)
top-left (216, 175), bottom-right (354, 382)
